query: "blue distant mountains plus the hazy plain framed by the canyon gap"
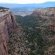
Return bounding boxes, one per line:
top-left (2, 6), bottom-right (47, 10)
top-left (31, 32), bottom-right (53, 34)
top-left (0, 2), bottom-right (55, 16)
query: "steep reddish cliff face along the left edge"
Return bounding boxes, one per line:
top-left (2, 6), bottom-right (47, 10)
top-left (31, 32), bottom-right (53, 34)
top-left (0, 10), bottom-right (16, 55)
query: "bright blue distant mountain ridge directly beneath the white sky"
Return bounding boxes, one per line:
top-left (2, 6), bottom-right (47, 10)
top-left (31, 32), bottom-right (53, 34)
top-left (0, 2), bottom-right (55, 8)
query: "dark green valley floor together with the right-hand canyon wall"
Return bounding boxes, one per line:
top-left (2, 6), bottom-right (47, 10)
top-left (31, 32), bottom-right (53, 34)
top-left (13, 8), bottom-right (55, 55)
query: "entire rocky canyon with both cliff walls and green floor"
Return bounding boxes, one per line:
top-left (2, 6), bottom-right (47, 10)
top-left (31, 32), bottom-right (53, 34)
top-left (0, 7), bottom-right (55, 55)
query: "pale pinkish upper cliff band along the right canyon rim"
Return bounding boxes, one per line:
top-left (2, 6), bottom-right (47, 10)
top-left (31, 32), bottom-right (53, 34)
top-left (33, 7), bottom-right (55, 16)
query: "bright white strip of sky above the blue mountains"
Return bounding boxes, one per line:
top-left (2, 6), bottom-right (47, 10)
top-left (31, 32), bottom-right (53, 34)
top-left (0, 0), bottom-right (55, 4)
